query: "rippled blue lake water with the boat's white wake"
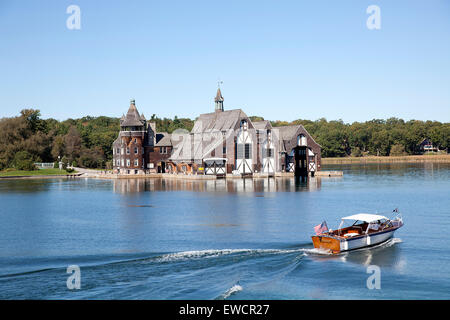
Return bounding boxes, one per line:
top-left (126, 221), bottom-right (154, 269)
top-left (0, 163), bottom-right (450, 299)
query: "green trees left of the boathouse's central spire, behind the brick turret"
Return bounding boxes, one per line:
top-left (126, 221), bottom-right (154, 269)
top-left (0, 109), bottom-right (194, 170)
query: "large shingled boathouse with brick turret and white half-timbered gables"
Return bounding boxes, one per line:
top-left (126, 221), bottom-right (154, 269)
top-left (113, 89), bottom-right (321, 175)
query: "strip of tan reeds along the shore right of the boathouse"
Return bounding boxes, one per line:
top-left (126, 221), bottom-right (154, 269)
top-left (322, 154), bottom-right (450, 165)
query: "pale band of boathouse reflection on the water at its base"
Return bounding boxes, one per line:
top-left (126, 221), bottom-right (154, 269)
top-left (113, 177), bottom-right (322, 193)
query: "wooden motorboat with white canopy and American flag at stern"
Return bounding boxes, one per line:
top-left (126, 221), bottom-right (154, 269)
top-left (312, 209), bottom-right (403, 254)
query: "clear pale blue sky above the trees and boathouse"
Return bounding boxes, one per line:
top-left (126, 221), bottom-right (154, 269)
top-left (0, 0), bottom-right (450, 122)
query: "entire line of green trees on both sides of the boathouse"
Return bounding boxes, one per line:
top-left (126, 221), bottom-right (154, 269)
top-left (0, 109), bottom-right (450, 170)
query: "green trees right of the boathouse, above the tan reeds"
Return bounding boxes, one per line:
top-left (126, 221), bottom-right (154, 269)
top-left (272, 118), bottom-right (450, 157)
